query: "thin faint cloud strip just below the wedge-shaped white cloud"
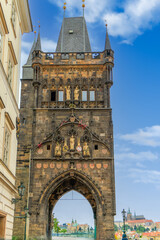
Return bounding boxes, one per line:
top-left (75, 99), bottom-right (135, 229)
top-left (115, 151), bottom-right (158, 162)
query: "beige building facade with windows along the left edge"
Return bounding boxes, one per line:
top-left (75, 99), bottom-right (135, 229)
top-left (0, 0), bottom-right (32, 239)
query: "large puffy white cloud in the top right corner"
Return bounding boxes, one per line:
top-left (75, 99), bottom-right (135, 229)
top-left (104, 0), bottom-right (160, 40)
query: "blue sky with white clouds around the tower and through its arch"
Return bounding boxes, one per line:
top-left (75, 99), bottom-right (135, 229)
top-left (21, 0), bottom-right (160, 225)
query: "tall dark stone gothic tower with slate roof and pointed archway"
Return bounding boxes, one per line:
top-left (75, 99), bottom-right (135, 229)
top-left (14, 17), bottom-right (115, 240)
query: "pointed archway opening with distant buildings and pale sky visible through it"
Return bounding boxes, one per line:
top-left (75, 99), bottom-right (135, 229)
top-left (52, 190), bottom-right (95, 240)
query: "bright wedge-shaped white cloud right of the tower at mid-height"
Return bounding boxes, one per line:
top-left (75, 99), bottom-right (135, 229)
top-left (120, 125), bottom-right (160, 147)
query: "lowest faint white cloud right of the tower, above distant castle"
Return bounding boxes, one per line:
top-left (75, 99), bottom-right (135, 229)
top-left (129, 168), bottom-right (160, 188)
